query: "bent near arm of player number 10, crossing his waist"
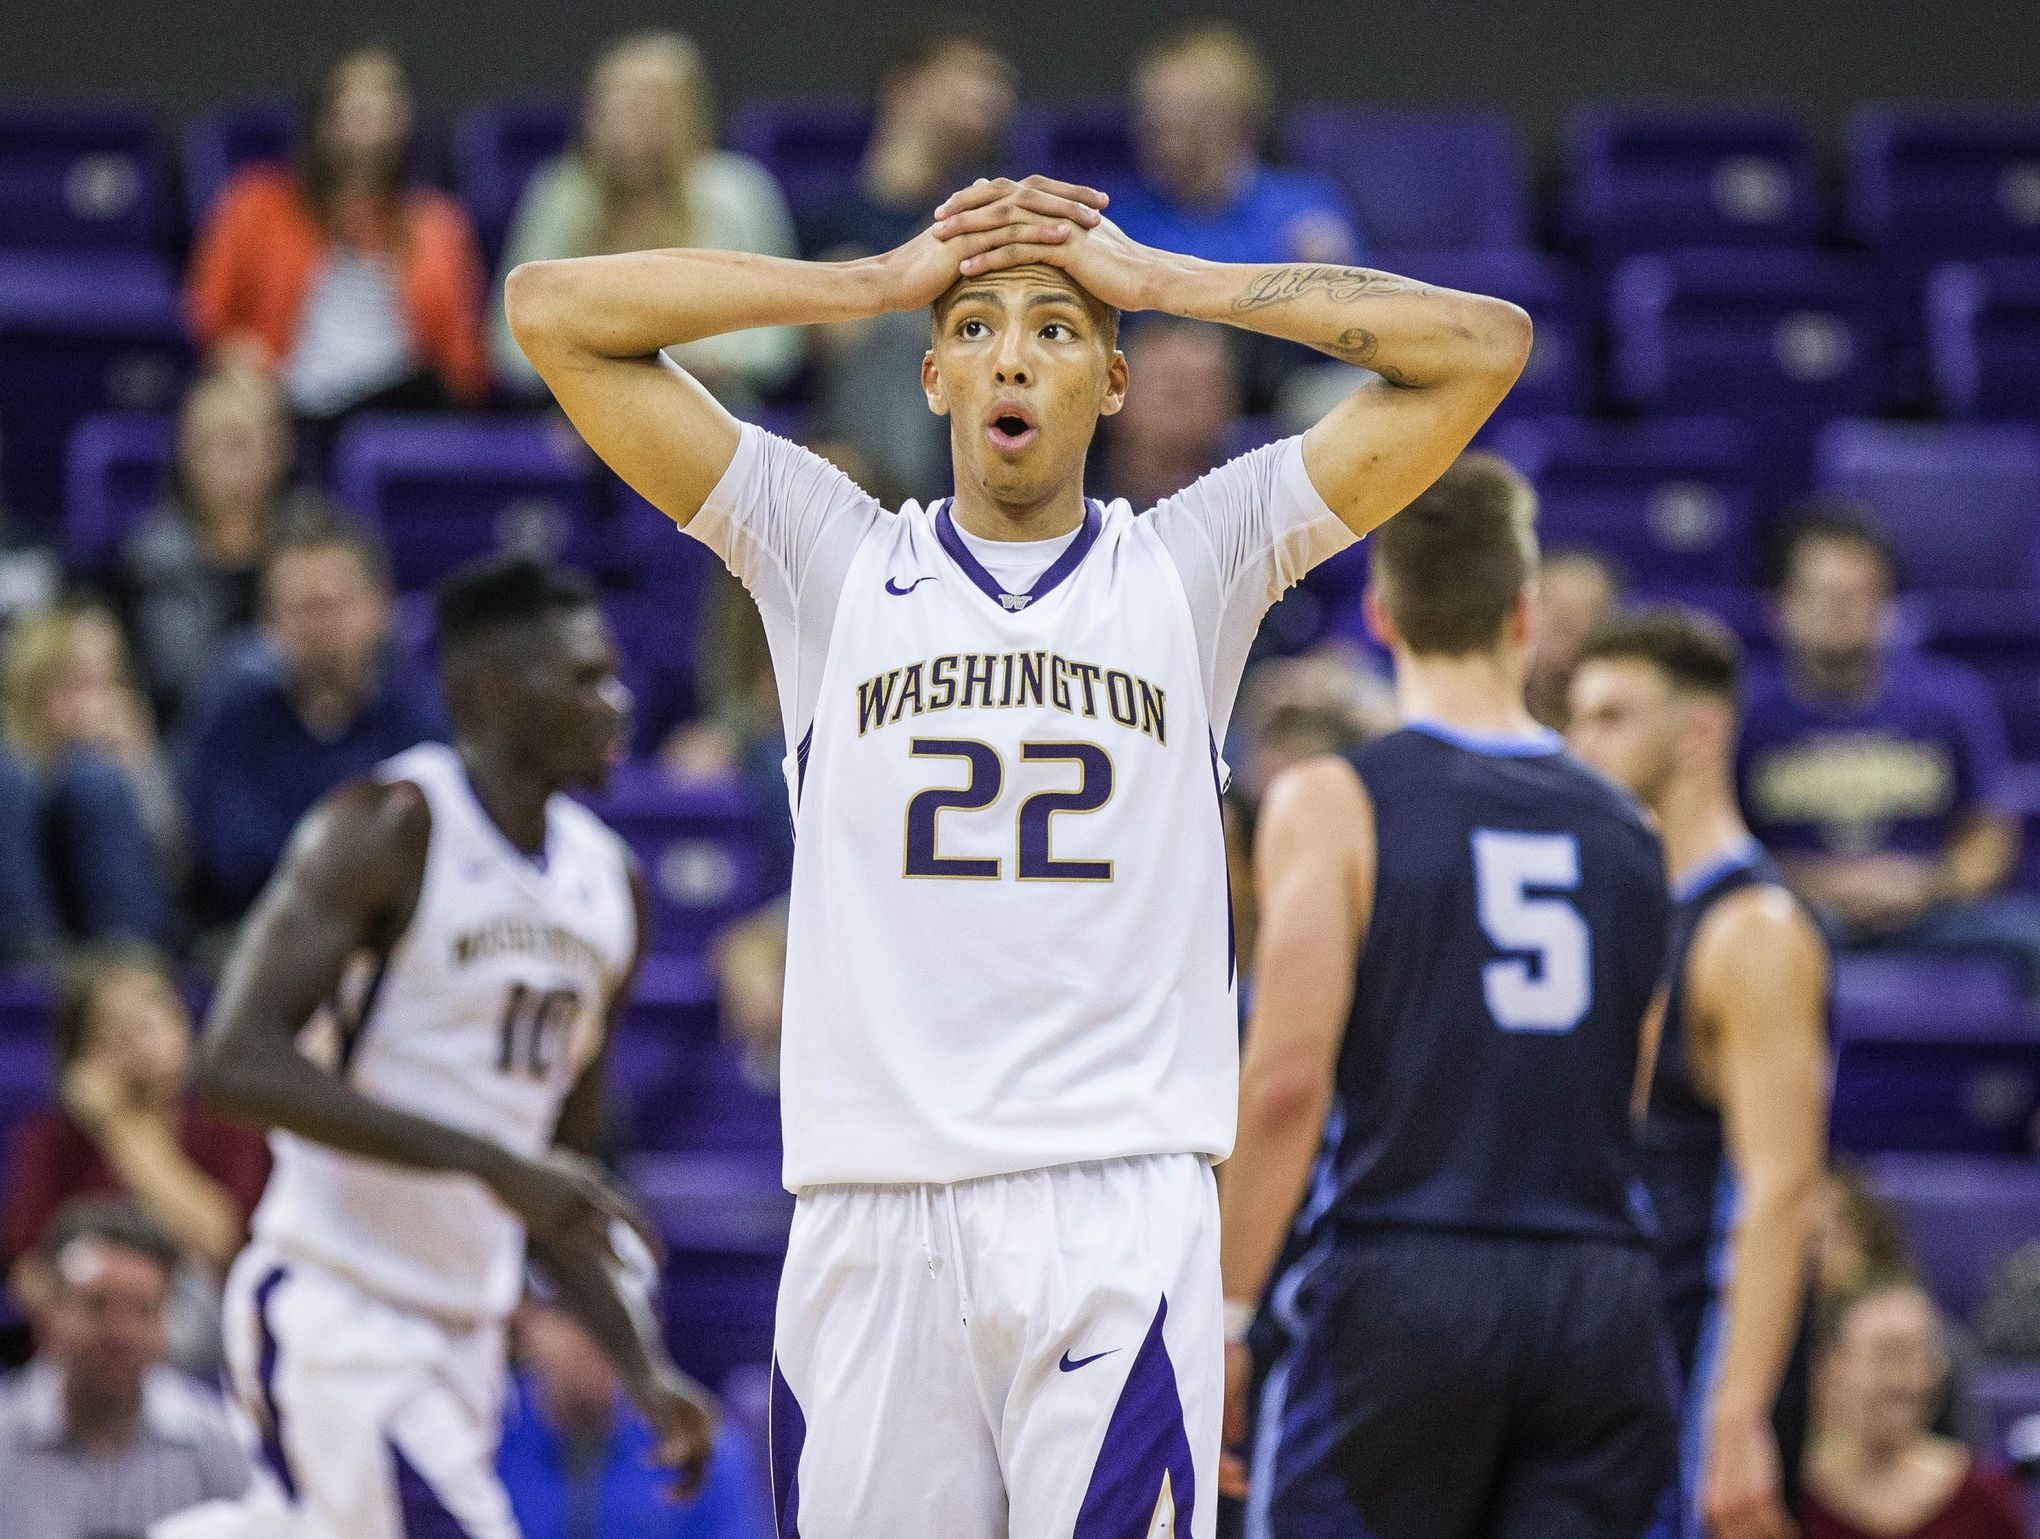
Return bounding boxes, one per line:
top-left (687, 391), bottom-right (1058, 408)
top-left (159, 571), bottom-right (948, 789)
top-left (200, 782), bottom-right (636, 1237)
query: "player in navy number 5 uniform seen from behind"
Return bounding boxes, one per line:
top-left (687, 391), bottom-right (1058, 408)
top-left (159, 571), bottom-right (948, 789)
top-left (1222, 453), bottom-right (1673, 1539)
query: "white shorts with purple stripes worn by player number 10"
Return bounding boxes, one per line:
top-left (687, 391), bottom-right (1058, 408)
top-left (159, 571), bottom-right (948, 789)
top-left (149, 1245), bottom-right (518, 1539)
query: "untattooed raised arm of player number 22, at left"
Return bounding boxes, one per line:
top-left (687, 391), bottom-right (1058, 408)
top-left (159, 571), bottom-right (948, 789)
top-left (506, 184), bottom-right (1104, 525)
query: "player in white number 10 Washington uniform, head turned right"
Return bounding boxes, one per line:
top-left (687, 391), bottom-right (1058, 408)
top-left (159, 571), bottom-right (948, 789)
top-left (157, 559), bottom-right (712, 1539)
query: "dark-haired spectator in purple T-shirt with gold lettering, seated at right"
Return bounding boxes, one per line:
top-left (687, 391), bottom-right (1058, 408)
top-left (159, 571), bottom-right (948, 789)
top-left (1740, 506), bottom-right (2040, 988)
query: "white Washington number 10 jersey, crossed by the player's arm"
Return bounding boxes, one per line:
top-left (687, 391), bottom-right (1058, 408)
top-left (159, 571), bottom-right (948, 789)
top-left (253, 743), bottom-right (636, 1321)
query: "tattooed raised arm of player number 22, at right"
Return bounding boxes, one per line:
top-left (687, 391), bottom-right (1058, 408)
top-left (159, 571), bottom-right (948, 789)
top-left (934, 178), bottom-right (1530, 535)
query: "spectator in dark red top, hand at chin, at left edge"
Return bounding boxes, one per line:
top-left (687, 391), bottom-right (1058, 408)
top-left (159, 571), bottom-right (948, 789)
top-left (4, 945), bottom-right (269, 1374)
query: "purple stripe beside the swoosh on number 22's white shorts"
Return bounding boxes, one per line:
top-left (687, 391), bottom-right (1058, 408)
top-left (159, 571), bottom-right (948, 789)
top-left (1071, 1298), bottom-right (1197, 1539)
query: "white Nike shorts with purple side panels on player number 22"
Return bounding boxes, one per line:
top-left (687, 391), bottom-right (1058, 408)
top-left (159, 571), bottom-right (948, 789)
top-left (771, 1155), bottom-right (1224, 1539)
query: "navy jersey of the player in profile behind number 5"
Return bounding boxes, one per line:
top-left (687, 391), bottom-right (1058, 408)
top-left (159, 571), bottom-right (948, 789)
top-left (1642, 839), bottom-right (1827, 1374)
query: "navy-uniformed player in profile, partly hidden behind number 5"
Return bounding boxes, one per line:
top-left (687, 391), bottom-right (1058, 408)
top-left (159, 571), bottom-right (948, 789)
top-left (1571, 608), bottom-right (1828, 1539)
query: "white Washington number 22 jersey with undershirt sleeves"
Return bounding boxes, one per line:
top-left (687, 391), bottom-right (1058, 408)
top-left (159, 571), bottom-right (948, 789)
top-left (687, 427), bottom-right (1353, 1190)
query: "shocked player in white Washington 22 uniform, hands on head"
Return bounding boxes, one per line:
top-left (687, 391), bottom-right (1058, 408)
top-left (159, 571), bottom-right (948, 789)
top-left (508, 178), bottom-right (1530, 1539)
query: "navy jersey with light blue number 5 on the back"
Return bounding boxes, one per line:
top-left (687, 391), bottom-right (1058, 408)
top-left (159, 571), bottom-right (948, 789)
top-left (1306, 725), bottom-right (1669, 1243)
